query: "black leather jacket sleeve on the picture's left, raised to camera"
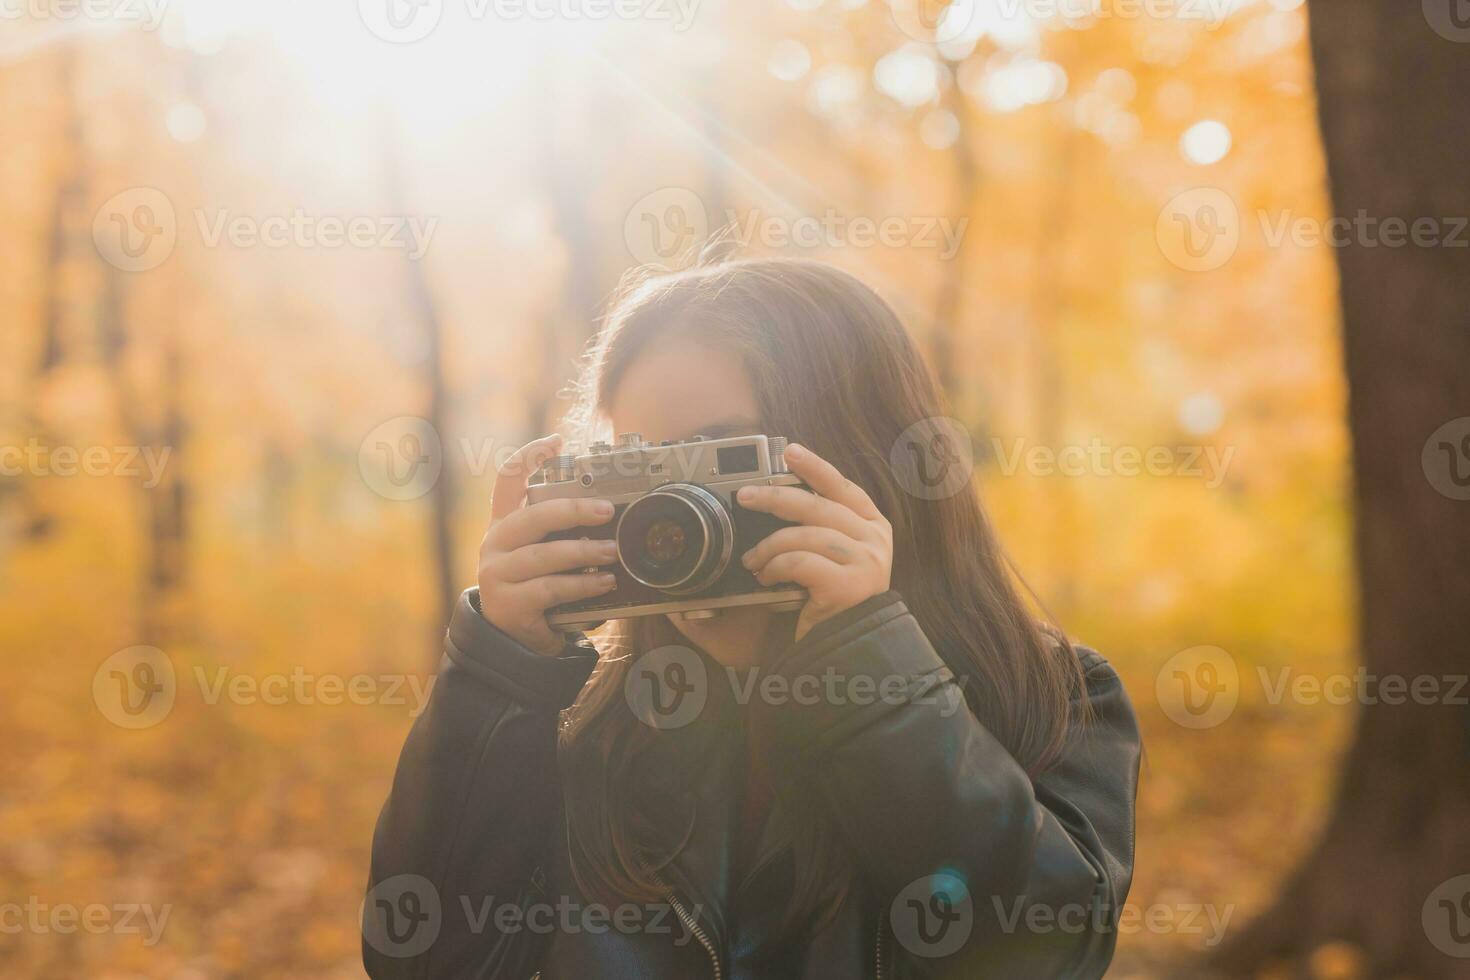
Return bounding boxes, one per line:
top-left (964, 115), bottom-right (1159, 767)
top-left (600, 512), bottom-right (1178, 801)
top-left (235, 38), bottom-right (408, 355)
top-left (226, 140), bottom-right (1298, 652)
top-left (362, 589), bottom-right (597, 980)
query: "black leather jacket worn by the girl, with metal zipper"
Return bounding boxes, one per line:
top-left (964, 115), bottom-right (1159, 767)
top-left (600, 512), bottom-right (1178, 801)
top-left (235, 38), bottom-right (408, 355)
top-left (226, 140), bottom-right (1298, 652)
top-left (363, 589), bottom-right (1139, 980)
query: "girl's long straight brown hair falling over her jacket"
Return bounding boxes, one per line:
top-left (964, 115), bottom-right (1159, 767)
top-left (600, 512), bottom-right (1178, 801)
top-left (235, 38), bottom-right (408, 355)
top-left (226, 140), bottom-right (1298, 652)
top-left (560, 259), bottom-right (1080, 924)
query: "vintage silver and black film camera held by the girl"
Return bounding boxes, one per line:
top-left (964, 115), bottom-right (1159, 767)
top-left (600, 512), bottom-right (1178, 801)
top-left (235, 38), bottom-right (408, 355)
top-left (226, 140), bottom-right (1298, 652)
top-left (526, 432), bottom-right (807, 632)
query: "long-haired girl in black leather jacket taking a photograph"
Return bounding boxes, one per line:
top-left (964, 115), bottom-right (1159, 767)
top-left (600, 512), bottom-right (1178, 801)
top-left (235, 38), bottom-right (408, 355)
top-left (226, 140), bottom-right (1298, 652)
top-left (363, 260), bottom-right (1139, 980)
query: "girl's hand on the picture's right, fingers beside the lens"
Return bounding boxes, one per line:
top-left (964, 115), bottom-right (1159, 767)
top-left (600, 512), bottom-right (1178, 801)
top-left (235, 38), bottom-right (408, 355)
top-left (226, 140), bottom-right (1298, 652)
top-left (736, 442), bottom-right (894, 641)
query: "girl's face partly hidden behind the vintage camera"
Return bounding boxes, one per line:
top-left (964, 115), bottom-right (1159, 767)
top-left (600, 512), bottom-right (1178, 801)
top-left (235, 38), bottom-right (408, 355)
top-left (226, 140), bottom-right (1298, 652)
top-left (609, 338), bottom-right (788, 667)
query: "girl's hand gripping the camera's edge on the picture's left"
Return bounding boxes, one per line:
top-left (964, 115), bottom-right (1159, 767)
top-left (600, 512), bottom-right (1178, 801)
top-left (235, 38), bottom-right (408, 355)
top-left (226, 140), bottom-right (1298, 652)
top-left (479, 435), bottom-right (617, 657)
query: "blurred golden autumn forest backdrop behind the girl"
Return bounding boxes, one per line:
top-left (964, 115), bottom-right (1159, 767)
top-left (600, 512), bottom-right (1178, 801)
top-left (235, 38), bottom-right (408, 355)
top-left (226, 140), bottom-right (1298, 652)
top-left (0, 0), bottom-right (1470, 979)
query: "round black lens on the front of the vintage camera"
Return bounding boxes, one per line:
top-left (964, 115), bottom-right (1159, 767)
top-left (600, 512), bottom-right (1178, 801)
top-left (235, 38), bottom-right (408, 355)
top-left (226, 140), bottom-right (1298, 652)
top-left (614, 483), bottom-right (735, 595)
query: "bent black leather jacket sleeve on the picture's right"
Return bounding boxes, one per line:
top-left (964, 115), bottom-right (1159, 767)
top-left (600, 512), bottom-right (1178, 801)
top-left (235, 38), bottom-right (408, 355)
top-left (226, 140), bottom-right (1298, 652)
top-left (761, 592), bottom-right (1141, 977)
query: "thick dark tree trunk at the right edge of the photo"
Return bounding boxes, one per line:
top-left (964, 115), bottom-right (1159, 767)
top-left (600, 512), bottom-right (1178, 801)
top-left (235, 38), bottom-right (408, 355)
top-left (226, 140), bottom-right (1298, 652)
top-left (1222, 0), bottom-right (1470, 977)
